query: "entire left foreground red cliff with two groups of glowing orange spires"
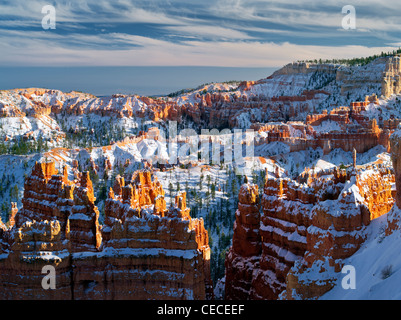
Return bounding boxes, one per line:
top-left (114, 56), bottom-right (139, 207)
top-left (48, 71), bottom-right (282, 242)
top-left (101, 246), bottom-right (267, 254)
top-left (0, 163), bottom-right (212, 299)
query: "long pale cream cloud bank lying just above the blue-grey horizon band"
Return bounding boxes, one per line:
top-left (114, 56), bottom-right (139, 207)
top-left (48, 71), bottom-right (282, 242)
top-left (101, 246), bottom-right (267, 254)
top-left (0, 28), bottom-right (394, 67)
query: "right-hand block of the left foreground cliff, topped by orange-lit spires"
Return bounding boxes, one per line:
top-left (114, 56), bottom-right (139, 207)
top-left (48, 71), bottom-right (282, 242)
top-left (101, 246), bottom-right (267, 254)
top-left (86, 185), bottom-right (211, 299)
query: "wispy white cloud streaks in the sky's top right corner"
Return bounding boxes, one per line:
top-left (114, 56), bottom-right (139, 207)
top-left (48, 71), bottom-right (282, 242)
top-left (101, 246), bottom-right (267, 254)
top-left (211, 0), bottom-right (401, 32)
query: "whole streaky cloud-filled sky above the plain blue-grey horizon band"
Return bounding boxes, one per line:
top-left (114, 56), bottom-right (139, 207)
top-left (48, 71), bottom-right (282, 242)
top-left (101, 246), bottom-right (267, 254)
top-left (0, 0), bottom-right (401, 67)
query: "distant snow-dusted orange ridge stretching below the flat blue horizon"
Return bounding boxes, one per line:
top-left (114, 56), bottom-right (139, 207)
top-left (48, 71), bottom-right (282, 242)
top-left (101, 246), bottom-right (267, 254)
top-left (0, 85), bottom-right (323, 128)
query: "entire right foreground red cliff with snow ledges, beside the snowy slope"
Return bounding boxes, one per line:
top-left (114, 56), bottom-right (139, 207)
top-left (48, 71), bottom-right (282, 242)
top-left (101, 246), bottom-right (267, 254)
top-left (226, 167), bottom-right (394, 299)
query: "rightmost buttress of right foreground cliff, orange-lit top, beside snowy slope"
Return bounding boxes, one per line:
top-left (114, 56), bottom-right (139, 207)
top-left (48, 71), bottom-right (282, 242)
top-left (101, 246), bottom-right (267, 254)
top-left (282, 168), bottom-right (393, 299)
